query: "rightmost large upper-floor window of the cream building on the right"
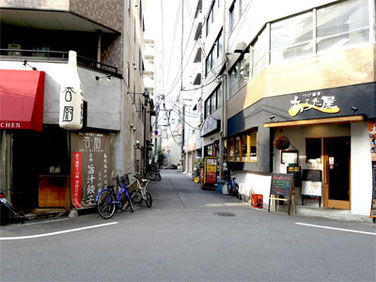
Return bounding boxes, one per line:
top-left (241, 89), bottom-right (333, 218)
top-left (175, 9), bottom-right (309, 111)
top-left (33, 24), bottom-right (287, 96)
top-left (316, 0), bottom-right (369, 52)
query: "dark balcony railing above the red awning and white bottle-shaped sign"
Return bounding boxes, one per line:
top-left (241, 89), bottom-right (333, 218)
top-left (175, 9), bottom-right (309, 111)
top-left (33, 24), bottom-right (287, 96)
top-left (0, 49), bottom-right (118, 74)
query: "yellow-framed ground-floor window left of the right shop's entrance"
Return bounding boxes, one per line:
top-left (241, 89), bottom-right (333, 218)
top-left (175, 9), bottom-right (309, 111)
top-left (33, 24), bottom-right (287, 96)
top-left (227, 129), bottom-right (257, 162)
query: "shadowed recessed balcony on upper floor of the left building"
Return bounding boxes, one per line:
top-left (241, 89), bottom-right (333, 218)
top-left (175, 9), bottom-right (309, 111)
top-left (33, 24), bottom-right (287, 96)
top-left (0, 8), bottom-right (121, 73)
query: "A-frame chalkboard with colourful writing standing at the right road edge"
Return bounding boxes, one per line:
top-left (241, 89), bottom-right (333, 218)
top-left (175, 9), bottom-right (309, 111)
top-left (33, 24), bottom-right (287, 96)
top-left (268, 173), bottom-right (294, 214)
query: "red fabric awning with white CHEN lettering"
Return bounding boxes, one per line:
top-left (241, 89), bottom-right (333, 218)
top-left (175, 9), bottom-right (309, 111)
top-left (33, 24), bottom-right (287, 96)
top-left (0, 70), bottom-right (45, 131)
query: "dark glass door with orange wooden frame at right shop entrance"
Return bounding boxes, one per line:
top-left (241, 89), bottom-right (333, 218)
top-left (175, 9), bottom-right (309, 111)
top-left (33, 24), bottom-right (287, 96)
top-left (324, 137), bottom-right (350, 210)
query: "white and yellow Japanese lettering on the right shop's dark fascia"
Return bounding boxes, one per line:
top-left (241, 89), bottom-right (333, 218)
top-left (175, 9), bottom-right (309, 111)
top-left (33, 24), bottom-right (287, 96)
top-left (288, 92), bottom-right (340, 117)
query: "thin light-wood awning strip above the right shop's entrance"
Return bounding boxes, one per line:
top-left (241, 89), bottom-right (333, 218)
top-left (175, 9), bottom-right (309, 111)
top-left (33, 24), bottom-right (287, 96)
top-left (264, 115), bottom-right (364, 127)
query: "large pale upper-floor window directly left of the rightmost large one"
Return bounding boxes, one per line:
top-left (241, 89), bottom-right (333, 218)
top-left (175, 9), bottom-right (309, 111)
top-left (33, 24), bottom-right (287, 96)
top-left (270, 12), bottom-right (313, 63)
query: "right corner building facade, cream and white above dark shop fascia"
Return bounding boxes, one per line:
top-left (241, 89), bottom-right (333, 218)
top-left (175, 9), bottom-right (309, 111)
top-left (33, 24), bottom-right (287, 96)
top-left (195, 0), bottom-right (376, 215)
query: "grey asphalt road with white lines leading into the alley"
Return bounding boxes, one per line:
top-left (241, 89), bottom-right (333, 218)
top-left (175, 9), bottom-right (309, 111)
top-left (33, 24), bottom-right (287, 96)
top-left (0, 171), bottom-right (376, 281)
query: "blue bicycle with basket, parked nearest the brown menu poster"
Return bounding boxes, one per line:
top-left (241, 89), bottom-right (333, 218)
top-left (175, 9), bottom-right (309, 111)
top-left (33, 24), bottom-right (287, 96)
top-left (96, 173), bottom-right (134, 219)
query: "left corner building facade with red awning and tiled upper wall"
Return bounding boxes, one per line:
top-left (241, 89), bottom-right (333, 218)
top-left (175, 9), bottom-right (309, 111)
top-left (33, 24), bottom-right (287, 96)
top-left (0, 0), bottom-right (152, 214)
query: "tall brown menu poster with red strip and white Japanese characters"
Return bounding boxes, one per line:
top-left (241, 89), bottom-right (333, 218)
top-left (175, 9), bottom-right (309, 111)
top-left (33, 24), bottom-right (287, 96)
top-left (71, 132), bottom-right (114, 209)
